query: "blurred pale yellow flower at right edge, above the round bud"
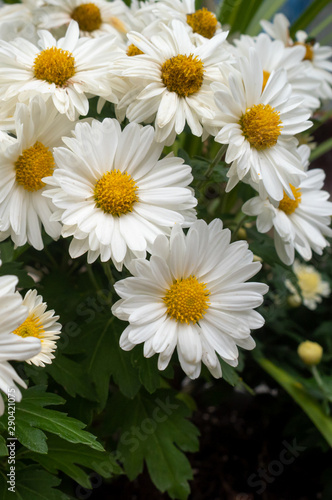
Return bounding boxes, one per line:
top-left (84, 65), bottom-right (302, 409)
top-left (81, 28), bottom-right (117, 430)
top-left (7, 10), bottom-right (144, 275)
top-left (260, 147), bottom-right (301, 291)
top-left (285, 260), bottom-right (331, 310)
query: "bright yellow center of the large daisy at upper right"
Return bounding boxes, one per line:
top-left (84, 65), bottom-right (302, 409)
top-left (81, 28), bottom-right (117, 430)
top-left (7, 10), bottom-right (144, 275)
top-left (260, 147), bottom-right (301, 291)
top-left (239, 104), bottom-right (282, 150)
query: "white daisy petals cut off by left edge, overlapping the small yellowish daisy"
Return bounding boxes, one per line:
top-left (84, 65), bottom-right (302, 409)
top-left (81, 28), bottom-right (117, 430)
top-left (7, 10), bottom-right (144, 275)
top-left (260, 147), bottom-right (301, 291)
top-left (0, 276), bottom-right (41, 415)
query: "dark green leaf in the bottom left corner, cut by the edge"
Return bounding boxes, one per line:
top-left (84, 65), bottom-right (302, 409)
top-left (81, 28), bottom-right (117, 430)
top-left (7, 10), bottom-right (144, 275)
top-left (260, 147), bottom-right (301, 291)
top-left (0, 466), bottom-right (69, 500)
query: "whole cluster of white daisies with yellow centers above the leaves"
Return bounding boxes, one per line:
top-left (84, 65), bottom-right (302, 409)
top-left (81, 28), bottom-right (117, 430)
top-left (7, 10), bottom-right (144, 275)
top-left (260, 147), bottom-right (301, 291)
top-left (0, 0), bottom-right (332, 406)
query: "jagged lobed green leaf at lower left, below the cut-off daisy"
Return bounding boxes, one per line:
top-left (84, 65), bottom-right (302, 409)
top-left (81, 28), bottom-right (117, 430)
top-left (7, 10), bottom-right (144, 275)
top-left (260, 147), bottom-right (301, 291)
top-left (2, 386), bottom-right (104, 453)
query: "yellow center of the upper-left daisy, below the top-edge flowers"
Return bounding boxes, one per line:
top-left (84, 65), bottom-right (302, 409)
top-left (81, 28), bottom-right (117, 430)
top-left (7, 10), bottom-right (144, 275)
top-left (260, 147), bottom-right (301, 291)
top-left (33, 47), bottom-right (75, 87)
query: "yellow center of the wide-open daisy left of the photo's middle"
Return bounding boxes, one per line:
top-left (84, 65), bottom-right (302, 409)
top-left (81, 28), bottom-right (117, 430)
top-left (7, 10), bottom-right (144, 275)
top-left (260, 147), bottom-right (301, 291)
top-left (94, 170), bottom-right (138, 216)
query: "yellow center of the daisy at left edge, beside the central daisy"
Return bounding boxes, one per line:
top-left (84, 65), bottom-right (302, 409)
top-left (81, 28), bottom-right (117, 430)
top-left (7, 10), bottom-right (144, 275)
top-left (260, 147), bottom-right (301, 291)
top-left (14, 141), bottom-right (55, 191)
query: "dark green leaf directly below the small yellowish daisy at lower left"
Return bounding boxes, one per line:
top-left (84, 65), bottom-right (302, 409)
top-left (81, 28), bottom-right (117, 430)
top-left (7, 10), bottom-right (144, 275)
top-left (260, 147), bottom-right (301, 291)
top-left (46, 352), bottom-right (96, 400)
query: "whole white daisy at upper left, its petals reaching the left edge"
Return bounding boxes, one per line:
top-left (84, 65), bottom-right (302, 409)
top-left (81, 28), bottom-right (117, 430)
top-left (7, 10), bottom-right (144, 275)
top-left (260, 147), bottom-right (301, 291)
top-left (0, 21), bottom-right (117, 120)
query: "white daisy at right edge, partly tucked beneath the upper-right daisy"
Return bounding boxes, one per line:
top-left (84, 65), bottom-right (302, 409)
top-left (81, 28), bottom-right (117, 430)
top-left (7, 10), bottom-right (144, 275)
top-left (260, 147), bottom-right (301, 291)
top-left (242, 145), bottom-right (332, 265)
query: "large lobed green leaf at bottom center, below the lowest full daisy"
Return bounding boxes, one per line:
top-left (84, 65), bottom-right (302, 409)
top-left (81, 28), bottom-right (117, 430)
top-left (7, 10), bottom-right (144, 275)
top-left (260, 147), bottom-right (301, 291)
top-left (110, 389), bottom-right (198, 500)
